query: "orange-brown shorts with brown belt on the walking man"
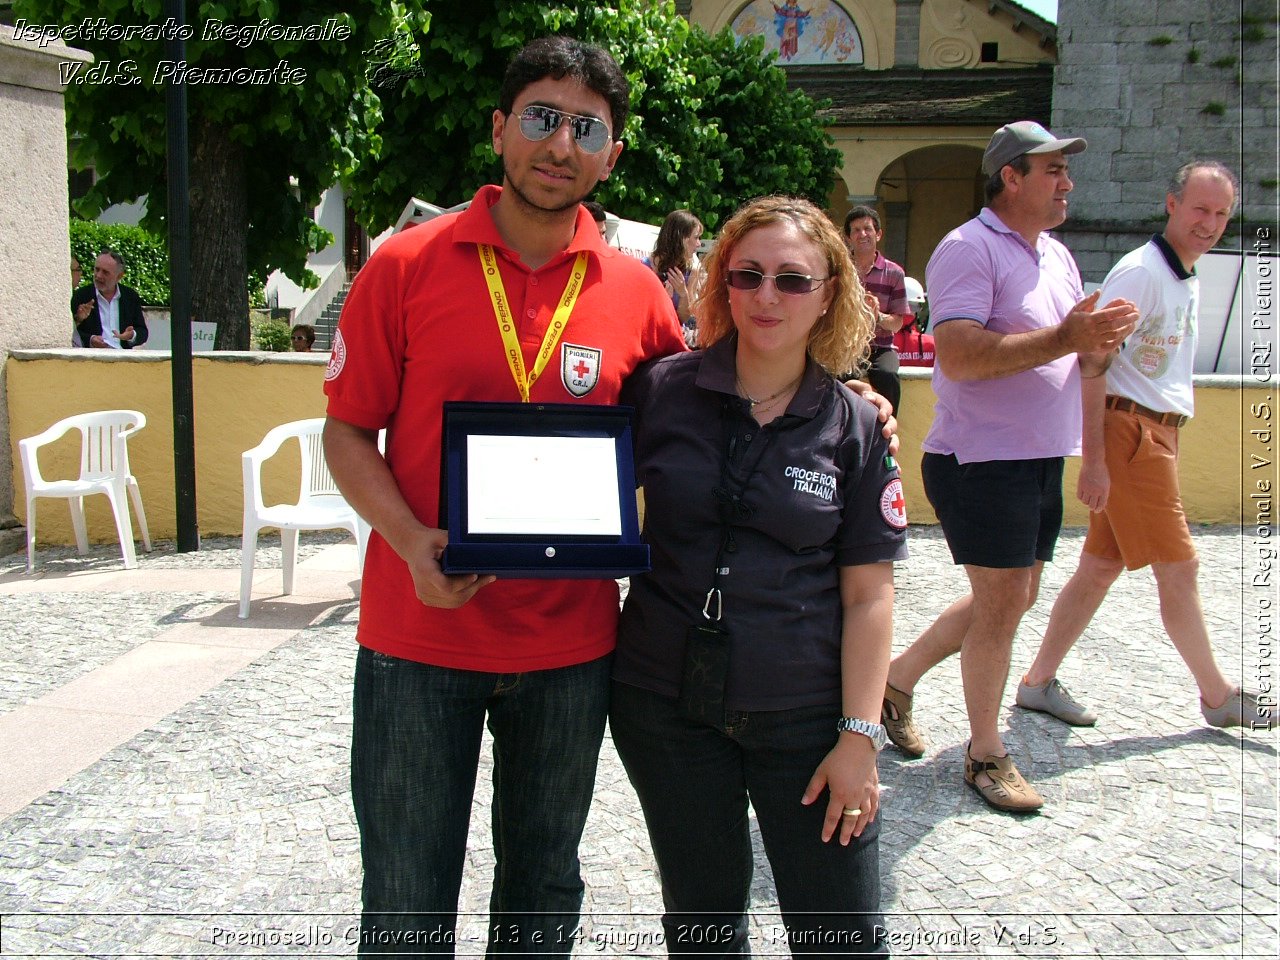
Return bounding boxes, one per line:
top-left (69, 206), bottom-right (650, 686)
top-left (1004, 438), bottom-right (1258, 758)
top-left (1083, 410), bottom-right (1196, 570)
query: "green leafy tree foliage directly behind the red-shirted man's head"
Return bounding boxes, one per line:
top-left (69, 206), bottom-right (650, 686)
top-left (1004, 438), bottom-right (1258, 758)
top-left (347, 0), bottom-right (840, 230)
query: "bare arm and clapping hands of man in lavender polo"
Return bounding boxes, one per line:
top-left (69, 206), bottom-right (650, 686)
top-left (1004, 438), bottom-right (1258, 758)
top-left (933, 291), bottom-right (1138, 381)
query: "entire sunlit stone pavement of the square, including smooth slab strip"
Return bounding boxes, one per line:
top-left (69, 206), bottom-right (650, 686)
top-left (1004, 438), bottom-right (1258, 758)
top-left (0, 529), bottom-right (1280, 957)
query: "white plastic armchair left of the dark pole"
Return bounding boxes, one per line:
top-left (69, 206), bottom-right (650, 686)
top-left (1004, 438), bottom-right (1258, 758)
top-left (18, 410), bottom-right (151, 573)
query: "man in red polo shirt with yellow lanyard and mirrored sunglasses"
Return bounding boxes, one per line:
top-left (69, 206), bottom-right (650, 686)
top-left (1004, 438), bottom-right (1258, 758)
top-left (325, 37), bottom-right (685, 955)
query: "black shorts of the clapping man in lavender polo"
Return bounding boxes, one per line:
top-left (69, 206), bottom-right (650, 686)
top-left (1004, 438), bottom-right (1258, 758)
top-left (920, 453), bottom-right (1064, 568)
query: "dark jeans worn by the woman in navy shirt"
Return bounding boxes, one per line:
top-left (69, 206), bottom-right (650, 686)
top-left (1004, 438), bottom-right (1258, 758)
top-left (609, 682), bottom-right (888, 956)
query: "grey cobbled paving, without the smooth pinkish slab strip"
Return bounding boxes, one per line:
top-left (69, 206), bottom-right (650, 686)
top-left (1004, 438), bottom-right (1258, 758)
top-left (0, 530), bottom-right (1280, 957)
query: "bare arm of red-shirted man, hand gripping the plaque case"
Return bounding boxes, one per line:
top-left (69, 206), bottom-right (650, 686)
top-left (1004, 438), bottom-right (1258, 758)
top-left (324, 416), bottom-right (497, 608)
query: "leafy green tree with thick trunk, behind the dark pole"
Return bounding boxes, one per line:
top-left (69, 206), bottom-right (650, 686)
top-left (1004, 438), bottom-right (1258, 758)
top-left (14, 0), bottom-right (425, 349)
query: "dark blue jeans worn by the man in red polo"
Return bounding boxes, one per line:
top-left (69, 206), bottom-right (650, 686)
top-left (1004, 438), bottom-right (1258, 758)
top-left (351, 648), bottom-right (612, 956)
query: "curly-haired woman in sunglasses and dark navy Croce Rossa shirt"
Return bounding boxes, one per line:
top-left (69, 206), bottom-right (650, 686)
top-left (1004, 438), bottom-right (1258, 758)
top-left (611, 197), bottom-right (906, 955)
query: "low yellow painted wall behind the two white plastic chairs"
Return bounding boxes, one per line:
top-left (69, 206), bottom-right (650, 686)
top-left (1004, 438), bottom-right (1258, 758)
top-left (5, 349), bottom-right (328, 547)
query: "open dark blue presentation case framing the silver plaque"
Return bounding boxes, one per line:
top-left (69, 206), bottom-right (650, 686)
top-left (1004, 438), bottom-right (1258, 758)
top-left (439, 401), bottom-right (649, 580)
